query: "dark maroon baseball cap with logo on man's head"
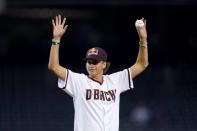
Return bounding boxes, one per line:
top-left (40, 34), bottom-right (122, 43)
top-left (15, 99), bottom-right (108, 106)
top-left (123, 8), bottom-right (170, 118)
top-left (84, 47), bottom-right (107, 61)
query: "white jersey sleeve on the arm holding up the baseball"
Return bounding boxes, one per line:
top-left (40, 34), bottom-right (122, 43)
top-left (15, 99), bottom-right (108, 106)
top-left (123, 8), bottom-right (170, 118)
top-left (109, 68), bottom-right (134, 93)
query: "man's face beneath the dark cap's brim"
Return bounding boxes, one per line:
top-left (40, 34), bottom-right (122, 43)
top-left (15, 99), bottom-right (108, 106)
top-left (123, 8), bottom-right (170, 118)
top-left (86, 59), bottom-right (106, 77)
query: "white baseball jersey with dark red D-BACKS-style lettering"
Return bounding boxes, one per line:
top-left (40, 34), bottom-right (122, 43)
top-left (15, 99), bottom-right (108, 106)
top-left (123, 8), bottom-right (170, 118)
top-left (58, 69), bottom-right (133, 131)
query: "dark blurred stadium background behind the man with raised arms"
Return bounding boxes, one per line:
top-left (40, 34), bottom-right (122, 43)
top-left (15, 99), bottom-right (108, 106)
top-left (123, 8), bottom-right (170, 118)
top-left (0, 0), bottom-right (197, 131)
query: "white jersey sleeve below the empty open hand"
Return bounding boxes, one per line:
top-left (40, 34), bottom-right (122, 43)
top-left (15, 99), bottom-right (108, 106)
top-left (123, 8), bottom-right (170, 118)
top-left (58, 69), bottom-right (82, 97)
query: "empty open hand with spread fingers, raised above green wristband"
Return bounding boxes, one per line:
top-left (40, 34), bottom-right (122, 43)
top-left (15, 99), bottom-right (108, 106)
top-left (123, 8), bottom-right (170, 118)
top-left (52, 15), bottom-right (68, 40)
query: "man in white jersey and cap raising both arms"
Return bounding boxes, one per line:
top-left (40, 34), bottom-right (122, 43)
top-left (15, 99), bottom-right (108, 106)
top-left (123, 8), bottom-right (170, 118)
top-left (48, 15), bottom-right (148, 131)
